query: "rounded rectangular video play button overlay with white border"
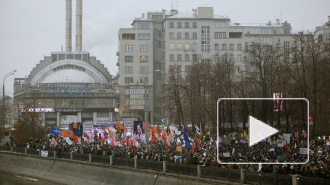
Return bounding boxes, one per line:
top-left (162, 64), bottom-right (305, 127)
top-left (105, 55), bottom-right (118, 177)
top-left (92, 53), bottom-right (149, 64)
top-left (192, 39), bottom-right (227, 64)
top-left (217, 98), bottom-right (309, 164)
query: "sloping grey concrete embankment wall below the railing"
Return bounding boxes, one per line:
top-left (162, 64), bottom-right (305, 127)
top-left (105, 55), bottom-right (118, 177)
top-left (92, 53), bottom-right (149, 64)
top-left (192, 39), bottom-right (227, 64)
top-left (0, 152), bottom-right (238, 185)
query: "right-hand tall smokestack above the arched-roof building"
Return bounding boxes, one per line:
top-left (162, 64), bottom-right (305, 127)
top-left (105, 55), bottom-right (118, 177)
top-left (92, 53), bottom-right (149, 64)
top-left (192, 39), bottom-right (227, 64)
top-left (76, 0), bottom-right (82, 52)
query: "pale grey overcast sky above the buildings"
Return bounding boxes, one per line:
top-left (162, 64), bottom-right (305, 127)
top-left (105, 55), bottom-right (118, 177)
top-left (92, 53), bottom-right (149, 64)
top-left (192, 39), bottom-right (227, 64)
top-left (0, 0), bottom-right (330, 96)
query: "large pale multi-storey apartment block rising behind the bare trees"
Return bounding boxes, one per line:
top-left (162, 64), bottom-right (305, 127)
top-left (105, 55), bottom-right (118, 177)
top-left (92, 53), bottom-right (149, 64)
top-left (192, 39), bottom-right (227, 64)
top-left (117, 7), bottom-right (328, 123)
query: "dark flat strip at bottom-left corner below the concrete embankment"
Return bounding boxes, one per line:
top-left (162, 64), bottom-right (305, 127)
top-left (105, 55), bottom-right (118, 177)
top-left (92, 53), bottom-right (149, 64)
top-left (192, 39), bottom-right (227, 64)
top-left (0, 171), bottom-right (64, 185)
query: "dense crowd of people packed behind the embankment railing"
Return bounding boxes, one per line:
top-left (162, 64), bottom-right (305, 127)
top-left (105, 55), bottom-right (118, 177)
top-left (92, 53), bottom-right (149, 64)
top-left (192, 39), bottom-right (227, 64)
top-left (7, 125), bottom-right (330, 179)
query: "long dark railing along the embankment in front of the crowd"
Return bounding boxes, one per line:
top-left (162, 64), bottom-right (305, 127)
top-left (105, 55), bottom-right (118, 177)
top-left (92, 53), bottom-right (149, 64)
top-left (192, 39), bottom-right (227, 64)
top-left (0, 146), bottom-right (330, 185)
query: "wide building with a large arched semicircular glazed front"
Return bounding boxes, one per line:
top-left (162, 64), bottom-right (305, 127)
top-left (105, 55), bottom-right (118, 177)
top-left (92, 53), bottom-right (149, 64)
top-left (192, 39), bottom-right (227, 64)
top-left (14, 52), bottom-right (117, 128)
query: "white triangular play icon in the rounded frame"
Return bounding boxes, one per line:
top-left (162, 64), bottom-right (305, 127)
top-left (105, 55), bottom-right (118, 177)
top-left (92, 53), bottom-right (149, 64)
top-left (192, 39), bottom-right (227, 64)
top-left (249, 116), bottom-right (278, 146)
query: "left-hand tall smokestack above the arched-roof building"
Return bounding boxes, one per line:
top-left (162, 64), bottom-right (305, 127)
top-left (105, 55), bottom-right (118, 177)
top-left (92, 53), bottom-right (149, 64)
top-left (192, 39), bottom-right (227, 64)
top-left (65, 0), bottom-right (72, 52)
